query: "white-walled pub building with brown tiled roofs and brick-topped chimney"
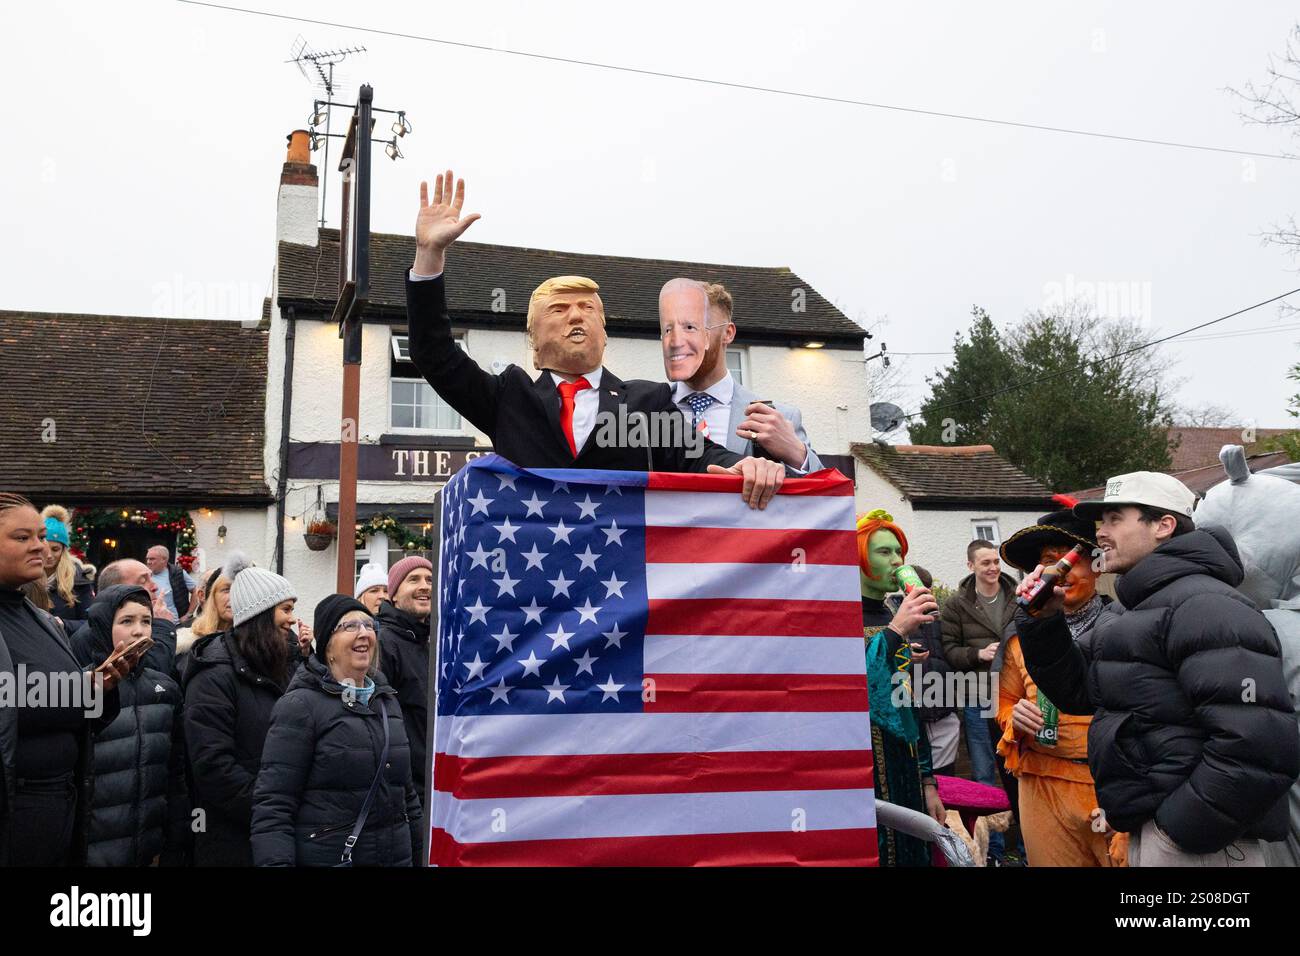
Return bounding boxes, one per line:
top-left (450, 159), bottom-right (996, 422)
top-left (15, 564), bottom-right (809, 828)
top-left (0, 131), bottom-right (872, 614)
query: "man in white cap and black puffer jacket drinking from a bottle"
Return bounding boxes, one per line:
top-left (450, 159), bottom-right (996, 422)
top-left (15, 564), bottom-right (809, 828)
top-left (1017, 472), bottom-right (1300, 866)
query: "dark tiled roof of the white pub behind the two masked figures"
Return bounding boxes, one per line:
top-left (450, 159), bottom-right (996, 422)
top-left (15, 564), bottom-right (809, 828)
top-left (280, 229), bottom-right (866, 349)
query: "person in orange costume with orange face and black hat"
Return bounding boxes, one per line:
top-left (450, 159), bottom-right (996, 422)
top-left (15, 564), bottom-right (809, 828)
top-left (995, 496), bottom-right (1128, 866)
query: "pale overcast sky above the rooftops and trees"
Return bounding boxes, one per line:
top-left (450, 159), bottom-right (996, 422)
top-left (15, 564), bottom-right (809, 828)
top-left (10, 0), bottom-right (1300, 425)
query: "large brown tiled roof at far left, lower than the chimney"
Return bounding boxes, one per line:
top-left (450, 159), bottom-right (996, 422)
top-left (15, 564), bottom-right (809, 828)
top-left (0, 311), bottom-right (270, 507)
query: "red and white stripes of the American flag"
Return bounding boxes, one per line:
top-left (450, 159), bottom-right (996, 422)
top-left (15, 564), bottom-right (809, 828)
top-left (430, 473), bottom-right (876, 865)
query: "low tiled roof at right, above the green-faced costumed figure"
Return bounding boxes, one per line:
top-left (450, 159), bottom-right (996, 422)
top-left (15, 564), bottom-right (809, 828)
top-left (853, 442), bottom-right (1052, 507)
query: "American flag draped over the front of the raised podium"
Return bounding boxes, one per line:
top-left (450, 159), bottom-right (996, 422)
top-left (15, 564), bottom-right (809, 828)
top-left (429, 455), bottom-right (876, 866)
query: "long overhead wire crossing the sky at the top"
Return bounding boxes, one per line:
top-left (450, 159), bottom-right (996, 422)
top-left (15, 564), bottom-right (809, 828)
top-left (177, 0), bottom-right (1300, 161)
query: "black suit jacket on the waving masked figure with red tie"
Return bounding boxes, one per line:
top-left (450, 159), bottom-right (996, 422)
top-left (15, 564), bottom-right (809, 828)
top-left (407, 276), bottom-right (741, 472)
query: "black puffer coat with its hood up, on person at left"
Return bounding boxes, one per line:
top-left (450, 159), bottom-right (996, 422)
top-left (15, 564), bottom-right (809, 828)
top-left (78, 584), bottom-right (190, 866)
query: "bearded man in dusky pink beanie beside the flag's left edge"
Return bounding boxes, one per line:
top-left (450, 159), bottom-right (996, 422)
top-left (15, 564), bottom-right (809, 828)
top-left (376, 555), bottom-right (433, 801)
